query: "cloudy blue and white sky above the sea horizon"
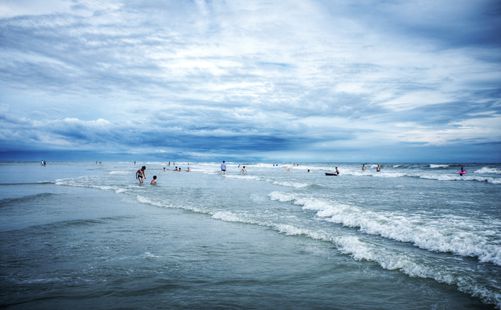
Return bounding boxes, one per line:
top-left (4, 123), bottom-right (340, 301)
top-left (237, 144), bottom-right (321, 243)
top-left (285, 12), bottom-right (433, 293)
top-left (0, 0), bottom-right (501, 162)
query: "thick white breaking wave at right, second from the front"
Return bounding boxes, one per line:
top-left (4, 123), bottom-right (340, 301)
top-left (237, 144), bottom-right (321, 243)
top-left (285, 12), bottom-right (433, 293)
top-left (269, 192), bottom-right (501, 266)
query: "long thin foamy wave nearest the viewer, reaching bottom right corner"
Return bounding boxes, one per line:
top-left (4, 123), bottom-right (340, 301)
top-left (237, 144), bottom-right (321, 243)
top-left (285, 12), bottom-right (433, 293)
top-left (137, 192), bottom-right (501, 306)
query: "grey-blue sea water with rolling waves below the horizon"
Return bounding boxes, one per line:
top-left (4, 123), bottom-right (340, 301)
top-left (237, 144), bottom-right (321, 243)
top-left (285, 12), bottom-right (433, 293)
top-left (0, 162), bottom-right (501, 309)
